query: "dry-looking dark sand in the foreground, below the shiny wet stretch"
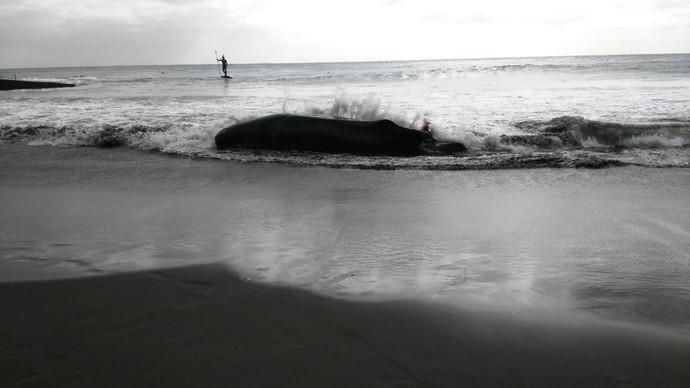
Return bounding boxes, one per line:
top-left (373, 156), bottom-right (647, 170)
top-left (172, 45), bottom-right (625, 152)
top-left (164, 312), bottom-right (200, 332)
top-left (0, 265), bottom-right (690, 387)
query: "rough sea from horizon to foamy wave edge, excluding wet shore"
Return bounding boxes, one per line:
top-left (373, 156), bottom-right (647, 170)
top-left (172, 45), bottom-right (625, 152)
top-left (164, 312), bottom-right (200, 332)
top-left (0, 54), bottom-right (690, 169)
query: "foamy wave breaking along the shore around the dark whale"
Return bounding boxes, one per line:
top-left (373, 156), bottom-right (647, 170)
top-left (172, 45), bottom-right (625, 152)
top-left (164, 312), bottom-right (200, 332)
top-left (0, 112), bottom-right (690, 170)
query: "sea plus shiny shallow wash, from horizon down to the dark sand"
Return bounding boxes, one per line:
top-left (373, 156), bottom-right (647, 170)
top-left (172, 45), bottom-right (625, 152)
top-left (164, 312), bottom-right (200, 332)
top-left (0, 55), bottom-right (690, 335)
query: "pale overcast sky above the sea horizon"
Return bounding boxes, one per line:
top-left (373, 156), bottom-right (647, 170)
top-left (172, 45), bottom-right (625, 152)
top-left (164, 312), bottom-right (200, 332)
top-left (0, 0), bottom-right (690, 68)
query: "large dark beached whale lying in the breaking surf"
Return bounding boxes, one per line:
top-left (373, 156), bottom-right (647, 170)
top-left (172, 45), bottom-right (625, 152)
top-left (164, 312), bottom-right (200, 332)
top-left (215, 114), bottom-right (465, 156)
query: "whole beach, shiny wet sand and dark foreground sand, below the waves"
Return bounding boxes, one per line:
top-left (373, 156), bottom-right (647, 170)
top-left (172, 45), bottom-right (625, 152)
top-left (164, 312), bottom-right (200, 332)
top-left (0, 144), bottom-right (690, 387)
